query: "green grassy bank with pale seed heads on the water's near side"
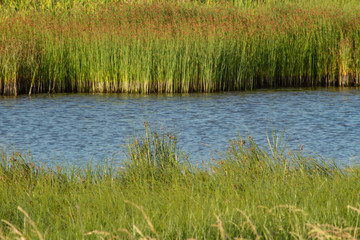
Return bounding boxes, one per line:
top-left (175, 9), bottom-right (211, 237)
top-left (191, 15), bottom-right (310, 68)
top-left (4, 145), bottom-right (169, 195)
top-left (0, 125), bottom-right (360, 239)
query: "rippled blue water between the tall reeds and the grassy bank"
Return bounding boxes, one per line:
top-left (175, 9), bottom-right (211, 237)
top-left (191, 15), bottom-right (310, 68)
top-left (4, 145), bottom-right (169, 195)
top-left (0, 89), bottom-right (360, 163)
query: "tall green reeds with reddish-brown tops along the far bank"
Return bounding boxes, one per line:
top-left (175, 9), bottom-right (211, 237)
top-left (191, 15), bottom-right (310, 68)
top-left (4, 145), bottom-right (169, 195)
top-left (0, 0), bottom-right (360, 95)
